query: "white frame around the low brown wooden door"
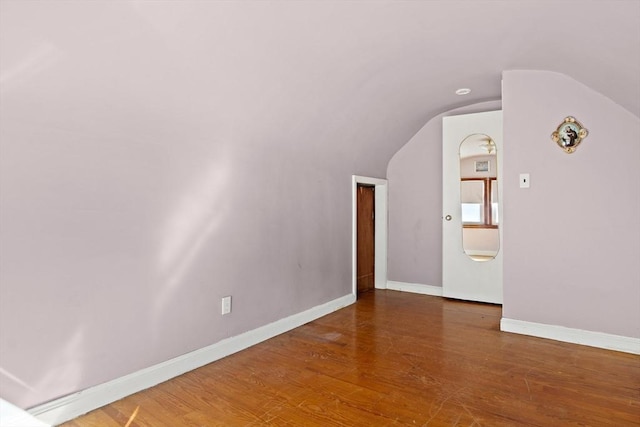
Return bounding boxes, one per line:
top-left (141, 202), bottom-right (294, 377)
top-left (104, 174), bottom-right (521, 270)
top-left (351, 175), bottom-right (388, 296)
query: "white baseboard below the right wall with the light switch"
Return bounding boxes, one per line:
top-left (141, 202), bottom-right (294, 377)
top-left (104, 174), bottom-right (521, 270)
top-left (500, 317), bottom-right (640, 354)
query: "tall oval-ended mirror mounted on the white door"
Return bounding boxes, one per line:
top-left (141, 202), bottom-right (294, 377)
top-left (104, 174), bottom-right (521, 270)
top-left (460, 134), bottom-right (500, 261)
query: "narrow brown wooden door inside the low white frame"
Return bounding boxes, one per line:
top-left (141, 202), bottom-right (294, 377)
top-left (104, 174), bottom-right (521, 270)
top-left (357, 185), bottom-right (375, 293)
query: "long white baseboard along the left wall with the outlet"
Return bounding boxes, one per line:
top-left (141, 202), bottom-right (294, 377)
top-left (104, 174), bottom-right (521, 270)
top-left (28, 294), bottom-right (356, 425)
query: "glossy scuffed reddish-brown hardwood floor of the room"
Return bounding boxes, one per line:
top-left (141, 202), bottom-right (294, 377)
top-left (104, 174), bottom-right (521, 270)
top-left (64, 290), bottom-right (640, 427)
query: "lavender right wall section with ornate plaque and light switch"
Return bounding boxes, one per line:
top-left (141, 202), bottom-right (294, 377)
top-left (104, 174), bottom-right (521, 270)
top-left (503, 71), bottom-right (640, 337)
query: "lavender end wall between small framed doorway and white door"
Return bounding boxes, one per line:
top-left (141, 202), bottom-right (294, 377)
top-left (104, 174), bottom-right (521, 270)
top-left (387, 101), bottom-right (501, 286)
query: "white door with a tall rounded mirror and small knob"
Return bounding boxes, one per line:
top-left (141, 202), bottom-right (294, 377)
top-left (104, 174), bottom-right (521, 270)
top-left (442, 111), bottom-right (503, 304)
